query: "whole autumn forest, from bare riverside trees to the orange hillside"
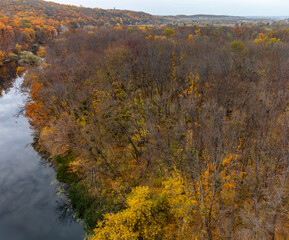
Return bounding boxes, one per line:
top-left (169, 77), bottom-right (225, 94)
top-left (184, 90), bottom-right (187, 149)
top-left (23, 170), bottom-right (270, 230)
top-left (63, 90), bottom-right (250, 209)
top-left (0, 0), bottom-right (289, 240)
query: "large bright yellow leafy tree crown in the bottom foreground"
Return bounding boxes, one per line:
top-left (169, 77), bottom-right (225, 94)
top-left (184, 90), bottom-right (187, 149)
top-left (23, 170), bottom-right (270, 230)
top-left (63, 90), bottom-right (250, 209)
top-left (91, 170), bottom-right (198, 240)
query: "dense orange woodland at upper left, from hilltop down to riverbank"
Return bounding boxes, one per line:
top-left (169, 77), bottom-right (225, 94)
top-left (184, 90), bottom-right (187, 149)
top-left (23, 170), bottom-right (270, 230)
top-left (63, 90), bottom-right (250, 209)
top-left (0, 0), bottom-right (156, 64)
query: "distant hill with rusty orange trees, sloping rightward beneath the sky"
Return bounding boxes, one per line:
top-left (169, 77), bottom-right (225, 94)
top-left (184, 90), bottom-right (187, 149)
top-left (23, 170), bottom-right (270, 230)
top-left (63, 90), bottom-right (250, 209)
top-left (0, 0), bottom-right (157, 27)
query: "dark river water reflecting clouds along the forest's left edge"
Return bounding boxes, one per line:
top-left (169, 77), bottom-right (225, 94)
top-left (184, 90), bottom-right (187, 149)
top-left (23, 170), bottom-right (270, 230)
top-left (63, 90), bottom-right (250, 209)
top-left (0, 78), bottom-right (85, 240)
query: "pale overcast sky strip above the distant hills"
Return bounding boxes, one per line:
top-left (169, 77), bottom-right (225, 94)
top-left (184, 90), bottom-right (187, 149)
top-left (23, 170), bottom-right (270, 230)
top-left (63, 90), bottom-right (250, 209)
top-left (45, 0), bottom-right (289, 16)
